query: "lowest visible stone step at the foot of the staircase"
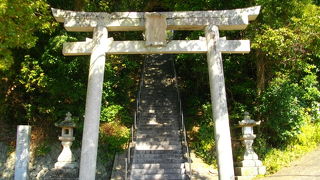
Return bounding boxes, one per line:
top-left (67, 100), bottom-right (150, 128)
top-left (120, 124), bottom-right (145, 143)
top-left (131, 174), bottom-right (188, 180)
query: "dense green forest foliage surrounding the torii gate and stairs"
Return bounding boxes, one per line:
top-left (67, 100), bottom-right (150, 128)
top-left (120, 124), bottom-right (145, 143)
top-left (0, 0), bottom-right (320, 173)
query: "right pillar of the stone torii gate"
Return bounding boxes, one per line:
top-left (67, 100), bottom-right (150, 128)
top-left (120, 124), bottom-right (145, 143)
top-left (205, 25), bottom-right (235, 180)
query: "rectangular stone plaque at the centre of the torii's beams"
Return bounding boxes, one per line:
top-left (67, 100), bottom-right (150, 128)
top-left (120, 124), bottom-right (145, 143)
top-left (144, 12), bottom-right (167, 46)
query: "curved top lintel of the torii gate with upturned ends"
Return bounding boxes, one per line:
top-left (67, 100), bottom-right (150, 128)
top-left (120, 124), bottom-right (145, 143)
top-left (52, 6), bottom-right (260, 32)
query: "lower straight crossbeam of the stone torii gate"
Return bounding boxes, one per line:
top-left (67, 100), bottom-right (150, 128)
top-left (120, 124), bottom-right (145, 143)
top-left (63, 39), bottom-right (250, 56)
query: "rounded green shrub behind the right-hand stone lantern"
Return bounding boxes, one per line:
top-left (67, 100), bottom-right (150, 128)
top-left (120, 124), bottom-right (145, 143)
top-left (259, 72), bottom-right (320, 146)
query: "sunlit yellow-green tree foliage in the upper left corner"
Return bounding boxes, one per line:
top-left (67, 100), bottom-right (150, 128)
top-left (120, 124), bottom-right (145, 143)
top-left (0, 0), bottom-right (56, 70)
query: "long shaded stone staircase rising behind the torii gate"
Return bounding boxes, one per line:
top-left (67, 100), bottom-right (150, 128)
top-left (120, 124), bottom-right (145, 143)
top-left (129, 55), bottom-right (189, 180)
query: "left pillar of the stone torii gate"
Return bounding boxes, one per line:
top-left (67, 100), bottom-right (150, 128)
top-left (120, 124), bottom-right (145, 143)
top-left (79, 25), bottom-right (112, 180)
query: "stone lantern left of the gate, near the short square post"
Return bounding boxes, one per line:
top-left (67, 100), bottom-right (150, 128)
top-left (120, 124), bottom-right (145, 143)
top-left (54, 112), bottom-right (77, 169)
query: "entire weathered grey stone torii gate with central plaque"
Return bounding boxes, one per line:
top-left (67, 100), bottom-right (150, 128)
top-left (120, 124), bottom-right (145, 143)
top-left (52, 6), bottom-right (260, 180)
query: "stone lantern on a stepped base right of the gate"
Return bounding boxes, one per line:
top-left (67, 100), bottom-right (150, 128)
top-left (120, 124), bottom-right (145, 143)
top-left (235, 112), bottom-right (266, 179)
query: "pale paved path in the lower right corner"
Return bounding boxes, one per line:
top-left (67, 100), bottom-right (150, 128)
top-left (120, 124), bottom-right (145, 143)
top-left (259, 146), bottom-right (320, 180)
